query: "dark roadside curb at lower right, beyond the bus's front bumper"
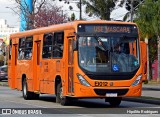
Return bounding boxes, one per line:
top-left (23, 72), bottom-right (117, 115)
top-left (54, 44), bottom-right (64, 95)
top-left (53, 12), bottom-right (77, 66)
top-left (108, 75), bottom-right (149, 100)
top-left (122, 97), bottom-right (160, 105)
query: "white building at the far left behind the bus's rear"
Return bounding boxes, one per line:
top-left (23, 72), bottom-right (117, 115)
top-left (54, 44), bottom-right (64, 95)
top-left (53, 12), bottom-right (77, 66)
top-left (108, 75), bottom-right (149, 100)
top-left (0, 19), bottom-right (19, 44)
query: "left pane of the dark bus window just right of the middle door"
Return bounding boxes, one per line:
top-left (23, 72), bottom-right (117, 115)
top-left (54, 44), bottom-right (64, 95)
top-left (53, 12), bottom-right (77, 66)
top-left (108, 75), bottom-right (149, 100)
top-left (42, 33), bottom-right (53, 58)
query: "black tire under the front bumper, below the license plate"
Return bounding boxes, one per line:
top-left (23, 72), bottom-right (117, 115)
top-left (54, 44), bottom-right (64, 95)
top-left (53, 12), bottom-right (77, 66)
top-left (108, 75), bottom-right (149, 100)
top-left (106, 97), bottom-right (122, 107)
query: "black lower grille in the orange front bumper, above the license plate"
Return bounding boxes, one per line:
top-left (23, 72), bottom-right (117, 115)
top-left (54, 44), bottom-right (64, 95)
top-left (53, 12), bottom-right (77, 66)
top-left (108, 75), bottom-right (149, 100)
top-left (94, 89), bottom-right (128, 96)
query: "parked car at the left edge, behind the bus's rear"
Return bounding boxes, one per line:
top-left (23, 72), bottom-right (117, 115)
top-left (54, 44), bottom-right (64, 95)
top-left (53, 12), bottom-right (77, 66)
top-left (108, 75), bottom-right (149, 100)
top-left (0, 65), bottom-right (8, 81)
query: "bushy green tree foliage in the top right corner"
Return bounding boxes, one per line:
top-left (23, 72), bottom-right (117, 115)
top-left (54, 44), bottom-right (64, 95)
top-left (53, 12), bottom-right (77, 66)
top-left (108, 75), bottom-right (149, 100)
top-left (135, 0), bottom-right (160, 38)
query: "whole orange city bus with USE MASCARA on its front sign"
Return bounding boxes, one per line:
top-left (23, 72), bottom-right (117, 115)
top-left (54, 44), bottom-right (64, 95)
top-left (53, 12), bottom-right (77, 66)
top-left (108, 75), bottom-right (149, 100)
top-left (8, 20), bottom-right (143, 106)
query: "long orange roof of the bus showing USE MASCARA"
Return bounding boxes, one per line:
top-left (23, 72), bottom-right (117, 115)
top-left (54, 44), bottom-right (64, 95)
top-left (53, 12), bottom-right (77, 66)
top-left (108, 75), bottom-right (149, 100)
top-left (10, 20), bottom-right (136, 38)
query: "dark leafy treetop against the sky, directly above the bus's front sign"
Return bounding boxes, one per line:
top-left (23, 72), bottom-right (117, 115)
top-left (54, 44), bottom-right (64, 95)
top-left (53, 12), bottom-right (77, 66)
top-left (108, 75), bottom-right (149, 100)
top-left (82, 0), bottom-right (122, 20)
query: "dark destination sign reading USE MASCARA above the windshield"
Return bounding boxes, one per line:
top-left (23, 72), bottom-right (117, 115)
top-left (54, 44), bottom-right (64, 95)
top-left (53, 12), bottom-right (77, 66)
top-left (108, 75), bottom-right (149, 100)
top-left (78, 24), bottom-right (137, 33)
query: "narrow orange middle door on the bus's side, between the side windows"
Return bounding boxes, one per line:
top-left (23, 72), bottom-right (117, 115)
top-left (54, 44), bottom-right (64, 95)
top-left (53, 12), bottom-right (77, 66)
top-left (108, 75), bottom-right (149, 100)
top-left (33, 40), bottom-right (41, 91)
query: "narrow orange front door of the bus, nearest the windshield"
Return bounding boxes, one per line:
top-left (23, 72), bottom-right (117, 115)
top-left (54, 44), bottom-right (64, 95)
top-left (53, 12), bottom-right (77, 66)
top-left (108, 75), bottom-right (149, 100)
top-left (67, 37), bottom-right (74, 95)
